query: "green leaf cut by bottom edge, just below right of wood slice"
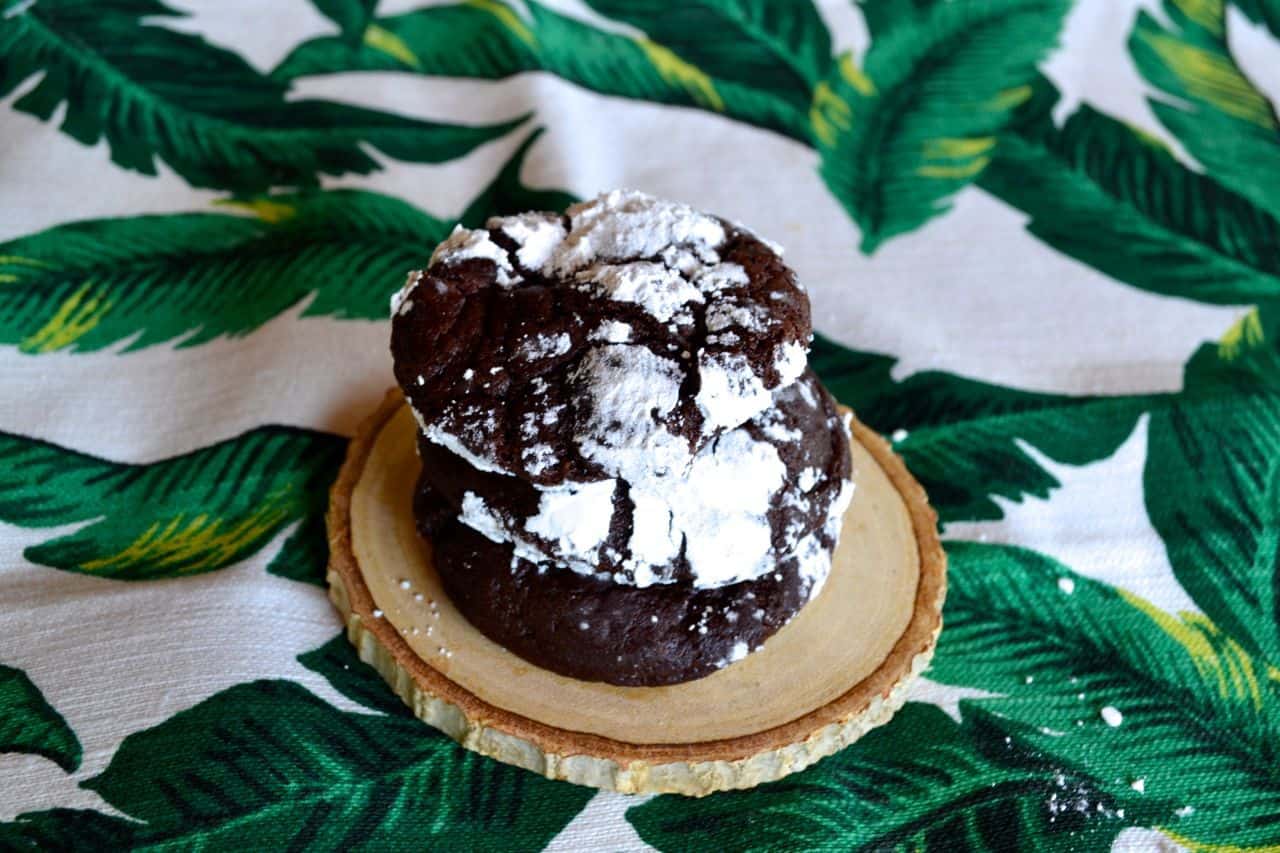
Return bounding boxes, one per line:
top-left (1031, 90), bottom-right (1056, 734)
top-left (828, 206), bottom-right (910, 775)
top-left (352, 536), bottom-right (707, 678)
top-left (627, 702), bottom-right (1125, 852)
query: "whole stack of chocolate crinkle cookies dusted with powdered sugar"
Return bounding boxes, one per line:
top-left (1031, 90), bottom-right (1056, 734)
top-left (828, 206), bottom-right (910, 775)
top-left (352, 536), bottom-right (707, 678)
top-left (392, 191), bottom-right (852, 685)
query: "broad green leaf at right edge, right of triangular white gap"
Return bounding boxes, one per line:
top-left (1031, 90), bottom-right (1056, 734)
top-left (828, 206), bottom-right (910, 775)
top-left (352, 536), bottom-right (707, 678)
top-left (1143, 392), bottom-right (1280, 671)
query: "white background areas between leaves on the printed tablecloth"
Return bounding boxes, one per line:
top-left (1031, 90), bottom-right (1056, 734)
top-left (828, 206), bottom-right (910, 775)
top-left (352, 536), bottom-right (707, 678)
top-left (0, 0), bottom-right (1280, 849)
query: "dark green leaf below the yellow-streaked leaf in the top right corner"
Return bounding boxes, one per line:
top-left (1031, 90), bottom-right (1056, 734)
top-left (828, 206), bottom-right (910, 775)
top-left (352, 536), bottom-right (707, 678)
top-left (980, 82), bottom-right (1280, 305)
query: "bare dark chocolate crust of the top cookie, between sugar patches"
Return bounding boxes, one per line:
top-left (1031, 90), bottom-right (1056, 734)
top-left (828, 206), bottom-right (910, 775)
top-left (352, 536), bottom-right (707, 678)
top-left (392, 214), bottom-right (812, 485)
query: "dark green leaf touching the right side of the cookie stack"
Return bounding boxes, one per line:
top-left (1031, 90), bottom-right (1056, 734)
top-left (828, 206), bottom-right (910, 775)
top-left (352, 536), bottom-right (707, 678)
top-left (809, 336), bottom-right (1156, 521)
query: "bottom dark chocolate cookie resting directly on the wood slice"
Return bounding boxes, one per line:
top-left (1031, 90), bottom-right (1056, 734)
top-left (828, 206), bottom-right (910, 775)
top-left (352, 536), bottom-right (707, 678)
top-left (415, 468), bottom-right (835, 686)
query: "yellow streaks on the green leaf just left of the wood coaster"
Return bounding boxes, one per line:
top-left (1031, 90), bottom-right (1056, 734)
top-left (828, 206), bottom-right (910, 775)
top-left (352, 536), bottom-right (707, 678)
top-left (79, 503), bottom-right (289, 574)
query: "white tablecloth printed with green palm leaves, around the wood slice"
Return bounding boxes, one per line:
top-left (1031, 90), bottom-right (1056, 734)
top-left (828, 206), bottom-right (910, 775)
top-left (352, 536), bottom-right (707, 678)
top-left (0, 0), bottom-right (1280, 852)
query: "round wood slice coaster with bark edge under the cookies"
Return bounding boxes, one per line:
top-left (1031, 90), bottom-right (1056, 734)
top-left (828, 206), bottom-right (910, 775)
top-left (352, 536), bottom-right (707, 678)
top-left (328, 391), bottom-right (946, 795)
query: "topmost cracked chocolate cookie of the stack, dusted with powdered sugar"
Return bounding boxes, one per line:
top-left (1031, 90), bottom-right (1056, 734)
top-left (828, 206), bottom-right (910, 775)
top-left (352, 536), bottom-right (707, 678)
top-left (392, 191), bottom-right (810, 485)
